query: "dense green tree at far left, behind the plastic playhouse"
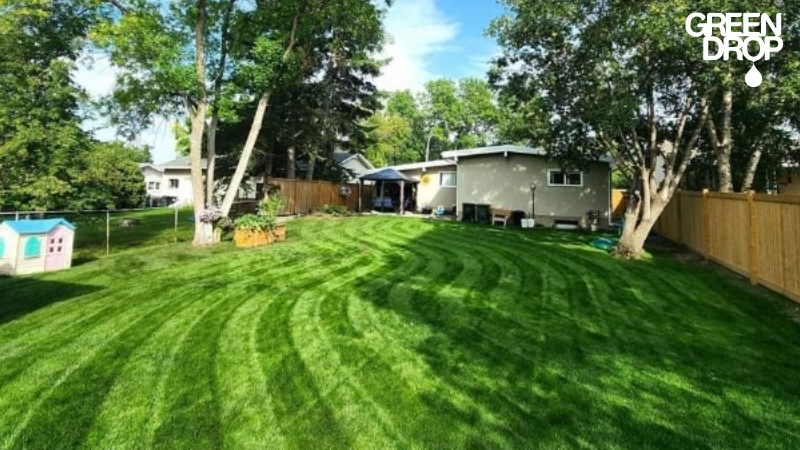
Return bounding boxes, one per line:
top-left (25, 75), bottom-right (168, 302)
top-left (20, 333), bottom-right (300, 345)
top-left (0, 0), bottom-right (103, 210)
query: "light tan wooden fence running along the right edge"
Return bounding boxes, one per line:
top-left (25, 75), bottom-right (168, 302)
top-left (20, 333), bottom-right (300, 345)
top-left (655, 191), bottom-right (800, 302)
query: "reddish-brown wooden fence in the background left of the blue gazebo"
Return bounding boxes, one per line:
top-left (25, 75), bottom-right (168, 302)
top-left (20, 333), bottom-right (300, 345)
top-left (269, 178), bottom-right (372, 214)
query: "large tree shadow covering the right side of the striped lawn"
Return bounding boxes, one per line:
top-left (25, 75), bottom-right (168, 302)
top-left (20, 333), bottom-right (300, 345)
top-left (358, 224), bottom-right (800, 448)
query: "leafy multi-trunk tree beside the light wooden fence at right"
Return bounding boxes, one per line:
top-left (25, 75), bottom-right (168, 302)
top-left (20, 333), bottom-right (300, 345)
top-left (490, 0), bottom-right (796, 257)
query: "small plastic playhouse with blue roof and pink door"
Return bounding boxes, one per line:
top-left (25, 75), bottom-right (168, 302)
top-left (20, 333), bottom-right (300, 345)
top-left (0, 219), bottom-right (75, 275)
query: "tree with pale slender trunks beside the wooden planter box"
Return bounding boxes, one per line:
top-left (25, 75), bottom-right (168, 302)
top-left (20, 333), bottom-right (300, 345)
top-left (96, 0), bottom-right (390, 245)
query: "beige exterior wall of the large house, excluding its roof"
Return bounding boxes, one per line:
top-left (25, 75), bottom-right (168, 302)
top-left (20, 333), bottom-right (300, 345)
top-left (458, 154), bottom-right (611, 226)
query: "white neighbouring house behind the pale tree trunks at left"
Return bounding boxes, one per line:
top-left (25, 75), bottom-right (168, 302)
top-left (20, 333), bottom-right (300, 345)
top-left (139, 156), bottom-right (207, 206)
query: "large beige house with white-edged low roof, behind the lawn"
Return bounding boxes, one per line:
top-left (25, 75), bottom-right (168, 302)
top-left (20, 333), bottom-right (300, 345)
top-left (442, 145), bottom-right (611, 226)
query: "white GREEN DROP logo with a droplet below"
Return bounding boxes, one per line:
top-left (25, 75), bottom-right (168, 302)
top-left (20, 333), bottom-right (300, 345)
top-left (686, 13), bottom-right (783, 87)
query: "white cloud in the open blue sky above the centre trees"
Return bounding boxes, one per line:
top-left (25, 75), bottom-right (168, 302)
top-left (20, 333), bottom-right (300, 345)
top-left (375, 0), bottom-right (458, 91)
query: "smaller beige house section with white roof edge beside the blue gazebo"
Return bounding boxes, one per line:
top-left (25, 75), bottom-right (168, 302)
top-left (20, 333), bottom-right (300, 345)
top-left (382, 159), bottom-right (458, 210)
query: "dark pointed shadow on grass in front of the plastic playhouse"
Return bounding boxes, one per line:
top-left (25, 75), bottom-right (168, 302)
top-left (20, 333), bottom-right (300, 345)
top-left (0, 276), bottom-right (101, 325)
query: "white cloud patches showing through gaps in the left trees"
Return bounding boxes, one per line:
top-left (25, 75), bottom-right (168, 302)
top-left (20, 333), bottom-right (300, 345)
top-left (73, 55), bottom-right (175, 163)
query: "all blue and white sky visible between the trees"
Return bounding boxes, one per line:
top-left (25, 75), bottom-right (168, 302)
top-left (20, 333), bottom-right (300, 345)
top-left (75, 0), bottom-right (510, 164)
